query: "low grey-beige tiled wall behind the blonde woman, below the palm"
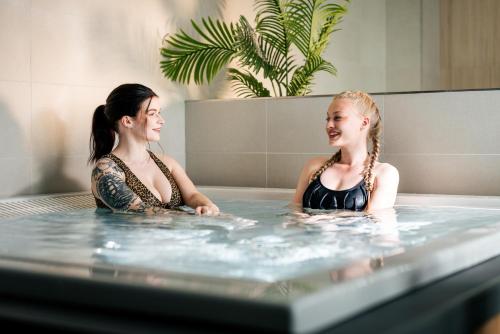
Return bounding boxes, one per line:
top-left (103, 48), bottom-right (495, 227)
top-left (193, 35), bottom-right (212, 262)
top-left (186, 90), bottom-right (500, 195)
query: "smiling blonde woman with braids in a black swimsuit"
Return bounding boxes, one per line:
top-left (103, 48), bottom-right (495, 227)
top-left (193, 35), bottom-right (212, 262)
top-left (293, 91), bottom-right (399, 211)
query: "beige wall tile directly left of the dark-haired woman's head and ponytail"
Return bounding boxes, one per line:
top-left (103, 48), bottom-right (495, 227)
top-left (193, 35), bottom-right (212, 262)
top-left (32, 84), bottom-right (108, 156)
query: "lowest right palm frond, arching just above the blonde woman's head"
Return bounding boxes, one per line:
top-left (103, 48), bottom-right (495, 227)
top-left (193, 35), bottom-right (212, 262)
top-left (288, 56), bottom-right (337, 96)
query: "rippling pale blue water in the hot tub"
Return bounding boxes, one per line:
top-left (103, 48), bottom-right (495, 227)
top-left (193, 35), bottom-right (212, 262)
top-left (0, 200), bottom-right (500, 282)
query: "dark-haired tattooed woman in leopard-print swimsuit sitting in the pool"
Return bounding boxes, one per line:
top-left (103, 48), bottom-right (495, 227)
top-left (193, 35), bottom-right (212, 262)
top-left (89, 84), bottom-right (219, 215)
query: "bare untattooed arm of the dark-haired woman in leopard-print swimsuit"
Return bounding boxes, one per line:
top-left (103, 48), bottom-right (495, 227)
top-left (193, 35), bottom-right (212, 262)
top-left (161, 155), bottom-right (219, 215)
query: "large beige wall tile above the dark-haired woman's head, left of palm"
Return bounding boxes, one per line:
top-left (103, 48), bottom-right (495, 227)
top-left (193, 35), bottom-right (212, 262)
top-left (32, 0), bottom-right (169, 86)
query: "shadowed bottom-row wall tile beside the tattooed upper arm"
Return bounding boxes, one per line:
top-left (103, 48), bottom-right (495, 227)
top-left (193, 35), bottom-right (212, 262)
top-left (32, 154), bottom-right (92, 194)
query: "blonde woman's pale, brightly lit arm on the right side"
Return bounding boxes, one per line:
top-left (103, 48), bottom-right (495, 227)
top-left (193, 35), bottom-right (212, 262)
top-left (367, 163), bottom-right (399, 211)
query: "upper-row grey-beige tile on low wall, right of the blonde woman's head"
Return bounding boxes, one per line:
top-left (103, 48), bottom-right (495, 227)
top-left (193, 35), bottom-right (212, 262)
top-left (385, 91), bottom-right (500, 154)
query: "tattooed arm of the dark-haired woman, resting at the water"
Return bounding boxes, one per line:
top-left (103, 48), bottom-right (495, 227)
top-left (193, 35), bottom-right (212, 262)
top-left (92, 159), bottom-right (170, 215)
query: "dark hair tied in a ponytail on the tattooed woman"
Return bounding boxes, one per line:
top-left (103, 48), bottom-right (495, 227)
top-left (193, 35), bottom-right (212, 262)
top-left (89, 84), bottom-right (158, 163)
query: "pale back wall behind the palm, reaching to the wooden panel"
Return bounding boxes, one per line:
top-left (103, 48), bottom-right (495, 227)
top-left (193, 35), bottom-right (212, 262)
top-left (185, 0), bottom-right (442, 99)
